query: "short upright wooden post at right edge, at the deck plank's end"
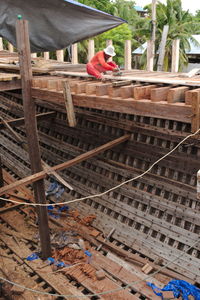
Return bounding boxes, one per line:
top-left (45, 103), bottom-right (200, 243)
top-left (191, 92), bottom-right (200, 133)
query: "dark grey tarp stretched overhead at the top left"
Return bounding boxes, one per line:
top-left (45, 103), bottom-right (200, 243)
top-left (0, 0), bottom-right (125, 52)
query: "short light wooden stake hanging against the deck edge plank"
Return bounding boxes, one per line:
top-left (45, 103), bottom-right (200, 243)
top-left (62, 81), bottom-right (76, 127)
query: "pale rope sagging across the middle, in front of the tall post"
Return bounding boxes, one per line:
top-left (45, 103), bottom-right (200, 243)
top-left (0, 128), bottom-right (200, 207)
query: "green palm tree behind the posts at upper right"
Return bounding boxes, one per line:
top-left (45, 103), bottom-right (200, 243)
top-left (141, 0), bottom-right (200, 71)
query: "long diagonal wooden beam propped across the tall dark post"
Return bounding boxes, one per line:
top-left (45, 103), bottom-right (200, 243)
top-left (0, 134), bottom-right (130, 195)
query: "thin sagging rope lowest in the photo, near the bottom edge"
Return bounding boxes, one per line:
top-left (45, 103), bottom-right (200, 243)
top-left (0, 236), bottom-right (200, 299)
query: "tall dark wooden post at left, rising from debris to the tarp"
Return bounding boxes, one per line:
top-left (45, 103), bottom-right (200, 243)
top-left (16, 20), bottom-right (51, 259)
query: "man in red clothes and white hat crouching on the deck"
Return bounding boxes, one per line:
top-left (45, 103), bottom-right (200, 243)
top-left (86, 45), bottom-right (119, 79)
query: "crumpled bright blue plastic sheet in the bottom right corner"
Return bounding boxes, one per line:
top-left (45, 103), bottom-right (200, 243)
top-left (147, 280), bottom-right (200, 300)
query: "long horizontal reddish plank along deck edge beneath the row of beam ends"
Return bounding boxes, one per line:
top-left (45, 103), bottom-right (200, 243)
top-left (32, 89), bottom-right (191, 123)
